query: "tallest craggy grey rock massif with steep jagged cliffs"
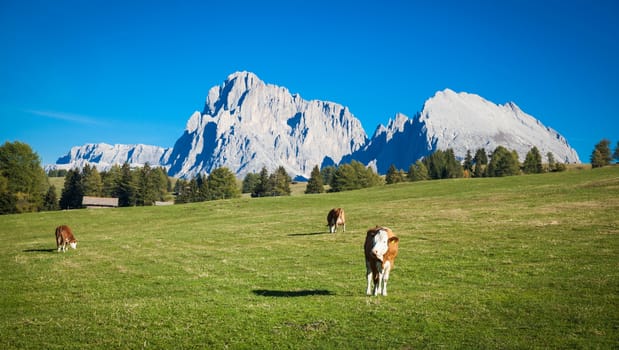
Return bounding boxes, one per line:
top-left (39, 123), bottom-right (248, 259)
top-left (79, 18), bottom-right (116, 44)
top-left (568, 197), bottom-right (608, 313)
top-left (170, 72), bottom-right (367, 177)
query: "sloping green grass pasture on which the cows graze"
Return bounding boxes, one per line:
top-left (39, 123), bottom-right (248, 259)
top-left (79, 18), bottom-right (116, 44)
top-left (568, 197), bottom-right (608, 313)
top-left (0, 167), bottom-right (619, 349)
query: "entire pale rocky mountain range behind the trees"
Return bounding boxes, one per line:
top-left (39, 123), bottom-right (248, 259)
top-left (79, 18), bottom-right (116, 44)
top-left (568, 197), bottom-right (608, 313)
top-left (55, 72), bottom-right (580, 178)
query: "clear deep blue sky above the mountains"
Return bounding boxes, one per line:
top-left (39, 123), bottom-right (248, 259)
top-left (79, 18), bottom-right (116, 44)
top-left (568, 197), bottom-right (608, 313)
top-left (0, 0), bottom-right (619, 164)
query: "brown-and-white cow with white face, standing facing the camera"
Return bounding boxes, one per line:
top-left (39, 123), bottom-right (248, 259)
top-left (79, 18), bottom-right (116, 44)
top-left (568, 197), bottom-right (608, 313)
top-left (364, 226), bottom-right (400, 295)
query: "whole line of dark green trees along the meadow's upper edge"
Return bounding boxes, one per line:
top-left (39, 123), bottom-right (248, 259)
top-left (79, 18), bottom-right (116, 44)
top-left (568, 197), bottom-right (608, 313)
top-left (0, 139), bottom-right (619, 214)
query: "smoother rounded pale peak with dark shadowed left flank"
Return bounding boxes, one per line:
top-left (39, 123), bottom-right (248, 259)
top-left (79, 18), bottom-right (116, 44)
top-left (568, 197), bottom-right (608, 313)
top-left (345, 89), bottom-right (580, 173)
